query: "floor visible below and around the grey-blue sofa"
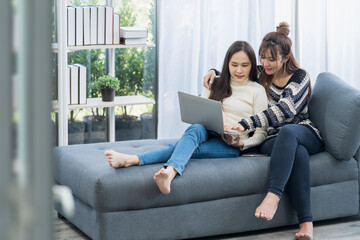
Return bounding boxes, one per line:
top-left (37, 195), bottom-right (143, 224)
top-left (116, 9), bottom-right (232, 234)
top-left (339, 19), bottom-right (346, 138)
top-left (54, 214), bottom-right (360, 240)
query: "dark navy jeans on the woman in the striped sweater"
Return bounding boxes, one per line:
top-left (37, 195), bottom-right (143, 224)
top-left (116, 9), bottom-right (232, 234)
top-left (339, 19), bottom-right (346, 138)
top-left (260, 124), bottom-right (323, 223)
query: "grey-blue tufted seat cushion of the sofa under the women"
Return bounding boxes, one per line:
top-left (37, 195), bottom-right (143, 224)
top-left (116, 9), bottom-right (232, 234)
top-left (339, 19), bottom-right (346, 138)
top-left (54, 140), bottom-right (358, 212)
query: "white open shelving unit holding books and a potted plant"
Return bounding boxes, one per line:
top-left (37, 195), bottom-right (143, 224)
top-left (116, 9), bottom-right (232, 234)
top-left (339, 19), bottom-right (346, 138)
top-left (51, 0), bottom-right (155, 146)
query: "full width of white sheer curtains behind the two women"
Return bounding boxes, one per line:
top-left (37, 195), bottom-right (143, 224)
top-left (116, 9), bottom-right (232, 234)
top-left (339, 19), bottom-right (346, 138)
top-left (158, 0), bottom-right (360, 138)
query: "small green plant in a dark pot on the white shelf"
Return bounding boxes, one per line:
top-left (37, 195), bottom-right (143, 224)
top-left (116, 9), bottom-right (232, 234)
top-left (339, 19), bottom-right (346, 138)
top-left (95, 73), bottom-right (120, 102)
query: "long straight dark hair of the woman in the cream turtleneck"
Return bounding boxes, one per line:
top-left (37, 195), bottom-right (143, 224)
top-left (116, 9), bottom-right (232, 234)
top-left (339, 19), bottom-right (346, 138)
top-left (209, 41), bottom-right (258, 101)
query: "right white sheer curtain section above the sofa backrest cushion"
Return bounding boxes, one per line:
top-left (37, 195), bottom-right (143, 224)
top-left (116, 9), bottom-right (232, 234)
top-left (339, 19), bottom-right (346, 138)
top-left (296, 0), bottom-right (360, 89)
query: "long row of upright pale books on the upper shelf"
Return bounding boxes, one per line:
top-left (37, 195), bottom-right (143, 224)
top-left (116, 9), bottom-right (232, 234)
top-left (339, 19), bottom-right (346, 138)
top-left (67, 6), bottom-right (120, 46)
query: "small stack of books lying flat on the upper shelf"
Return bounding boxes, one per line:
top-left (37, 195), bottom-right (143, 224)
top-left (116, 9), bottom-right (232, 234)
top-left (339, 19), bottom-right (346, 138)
top-left (120, 27), bottom-right (148, 45)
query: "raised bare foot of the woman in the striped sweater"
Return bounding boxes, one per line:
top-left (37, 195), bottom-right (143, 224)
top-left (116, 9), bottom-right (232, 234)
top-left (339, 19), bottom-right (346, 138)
top-left (255, 192), bottom-right (280, 221)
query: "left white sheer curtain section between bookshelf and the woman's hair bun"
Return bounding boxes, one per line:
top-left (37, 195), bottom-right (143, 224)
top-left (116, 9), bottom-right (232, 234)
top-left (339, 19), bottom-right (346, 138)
top-left (158, 0), bottom-right (274, 138)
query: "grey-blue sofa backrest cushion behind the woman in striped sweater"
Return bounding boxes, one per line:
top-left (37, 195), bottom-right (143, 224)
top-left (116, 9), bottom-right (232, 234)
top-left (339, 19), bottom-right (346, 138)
top-left (309, 72), bottom-right (360, 160)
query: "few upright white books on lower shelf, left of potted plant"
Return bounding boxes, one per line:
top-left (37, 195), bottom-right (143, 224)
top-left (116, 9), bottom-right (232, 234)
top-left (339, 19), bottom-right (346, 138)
top-left (66, 64), bottom-right (86, 104)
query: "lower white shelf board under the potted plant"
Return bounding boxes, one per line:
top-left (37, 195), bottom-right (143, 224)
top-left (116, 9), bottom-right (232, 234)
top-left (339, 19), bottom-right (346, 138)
top-left (52, 95), bottom-right (155, 112)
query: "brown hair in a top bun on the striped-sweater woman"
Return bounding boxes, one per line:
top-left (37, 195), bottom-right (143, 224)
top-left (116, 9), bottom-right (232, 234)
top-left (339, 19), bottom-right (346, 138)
top-left (259, 22), bottom-right (311, 96)
